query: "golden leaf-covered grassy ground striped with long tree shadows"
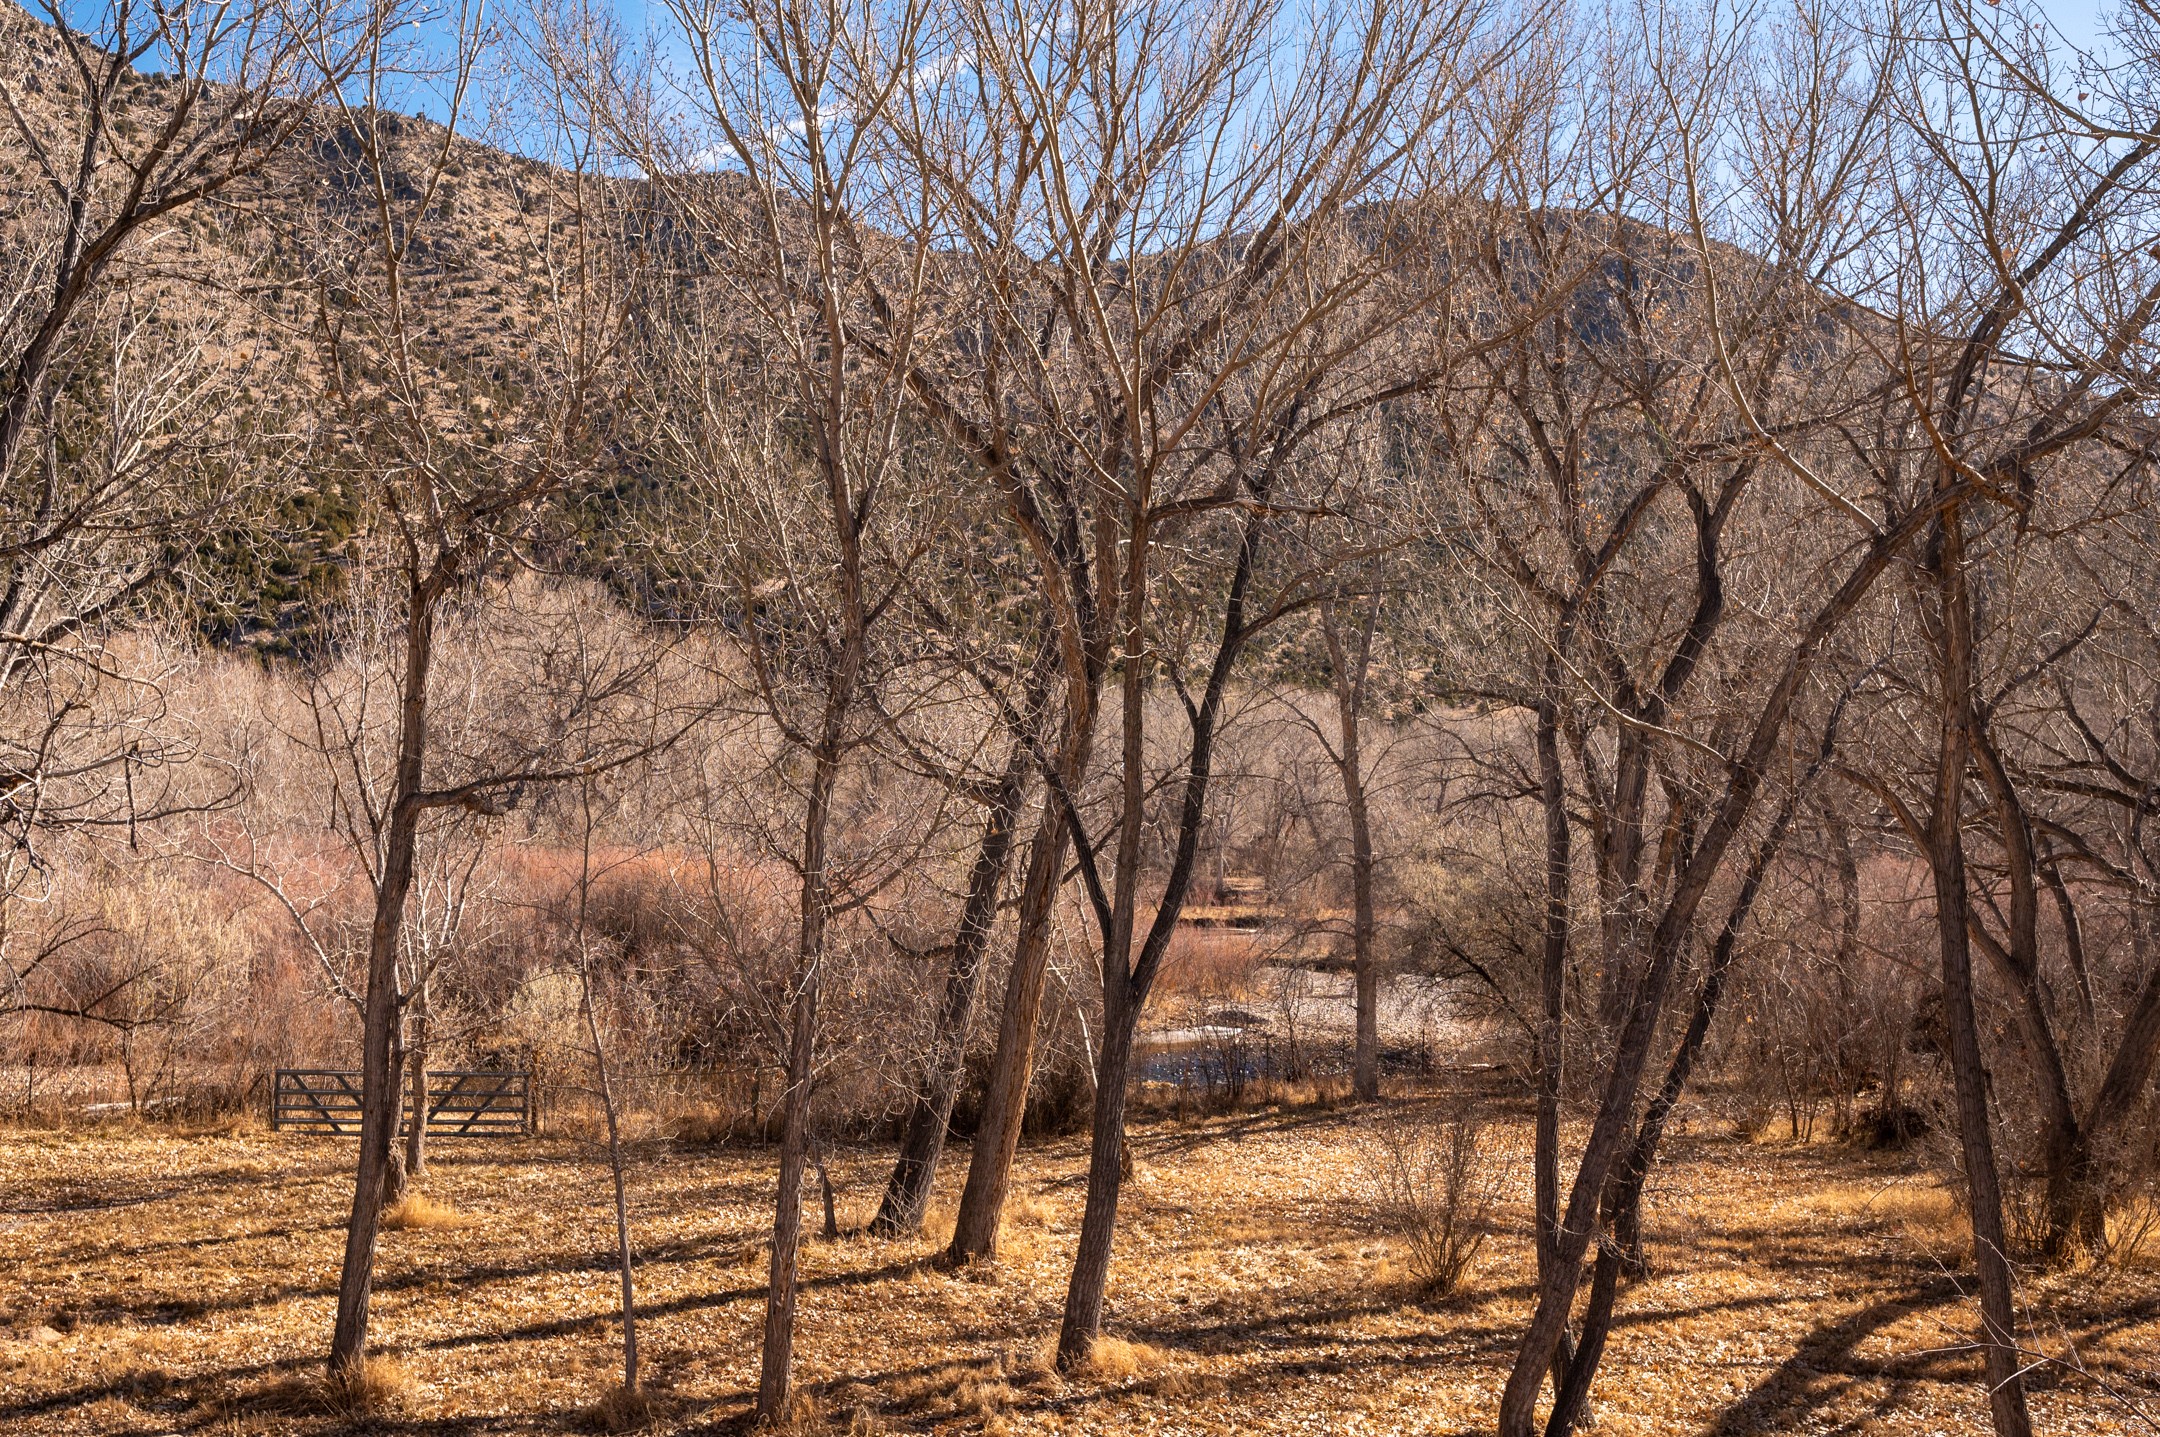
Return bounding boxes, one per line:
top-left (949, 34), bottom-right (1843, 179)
top-left (0, 1106), bottom-right (2160, 1437)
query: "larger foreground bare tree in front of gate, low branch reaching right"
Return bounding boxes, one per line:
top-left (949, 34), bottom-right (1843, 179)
top-left (276, 9), bottom-right (670, 1374)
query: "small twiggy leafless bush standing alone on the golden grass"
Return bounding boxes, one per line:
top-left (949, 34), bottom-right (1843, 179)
top-left (1365, 1096), bottom-right (1510, 1297)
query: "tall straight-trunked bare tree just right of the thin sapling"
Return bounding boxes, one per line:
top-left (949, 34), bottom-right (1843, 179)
top-left (620, 0), bottom-right (935, 1420)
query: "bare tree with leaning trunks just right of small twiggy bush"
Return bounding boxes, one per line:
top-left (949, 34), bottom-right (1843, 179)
top-left (1445, 6), bottom-right (2004, 1437)
